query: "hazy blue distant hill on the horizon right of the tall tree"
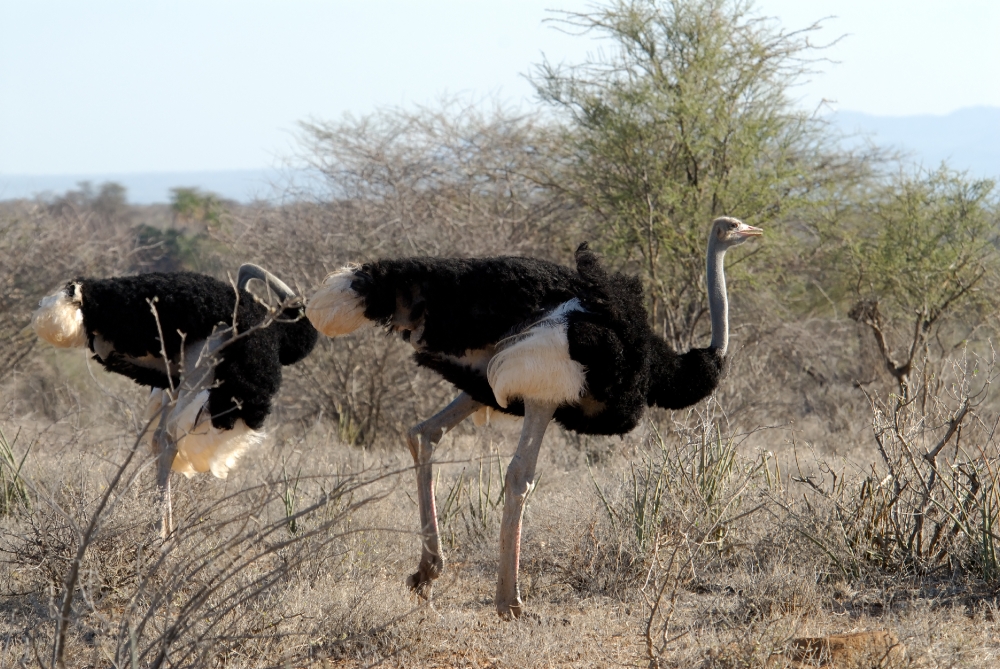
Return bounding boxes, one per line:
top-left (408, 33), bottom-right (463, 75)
top-left (830, 107), bottom-right (1000, 178)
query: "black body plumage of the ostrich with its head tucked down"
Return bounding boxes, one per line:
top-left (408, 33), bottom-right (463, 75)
top-left (72, 272), bottom-right (317, 430)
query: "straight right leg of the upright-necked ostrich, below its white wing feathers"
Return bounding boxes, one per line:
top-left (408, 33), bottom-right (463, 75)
top-left (496, 401), bottom-right (556, 618)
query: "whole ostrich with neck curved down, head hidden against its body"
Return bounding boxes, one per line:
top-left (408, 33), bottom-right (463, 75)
top-left (31, 264), bottom-right (318, 533)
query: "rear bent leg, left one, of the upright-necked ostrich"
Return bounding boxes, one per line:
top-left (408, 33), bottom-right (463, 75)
top-left (406, 393), bottom-right (482, 597)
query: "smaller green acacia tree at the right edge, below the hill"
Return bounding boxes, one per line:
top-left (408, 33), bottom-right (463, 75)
top-left (841, 167), bottom-right (1000, 398)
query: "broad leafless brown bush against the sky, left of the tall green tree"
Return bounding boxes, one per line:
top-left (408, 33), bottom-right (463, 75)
top-left (292, 101), bottom-right (582, 259)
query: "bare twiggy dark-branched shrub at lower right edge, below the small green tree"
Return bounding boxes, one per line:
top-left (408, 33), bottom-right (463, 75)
top-left (801, 353), bottom-right (1000, 583)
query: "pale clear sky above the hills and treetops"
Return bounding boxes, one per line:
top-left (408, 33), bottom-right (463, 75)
top-left (0, 0), bottom-right (1000, 175)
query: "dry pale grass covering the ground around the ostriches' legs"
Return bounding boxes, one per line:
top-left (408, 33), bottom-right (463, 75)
top-left (0, 362), bottom-right (1000, 667)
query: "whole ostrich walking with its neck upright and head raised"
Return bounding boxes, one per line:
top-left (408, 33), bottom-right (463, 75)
top-left (306, 217), bottom-right (762, 618)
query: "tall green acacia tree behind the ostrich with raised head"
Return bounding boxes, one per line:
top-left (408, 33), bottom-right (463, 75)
top-left (534, 0), bottom-right (847, 348)
